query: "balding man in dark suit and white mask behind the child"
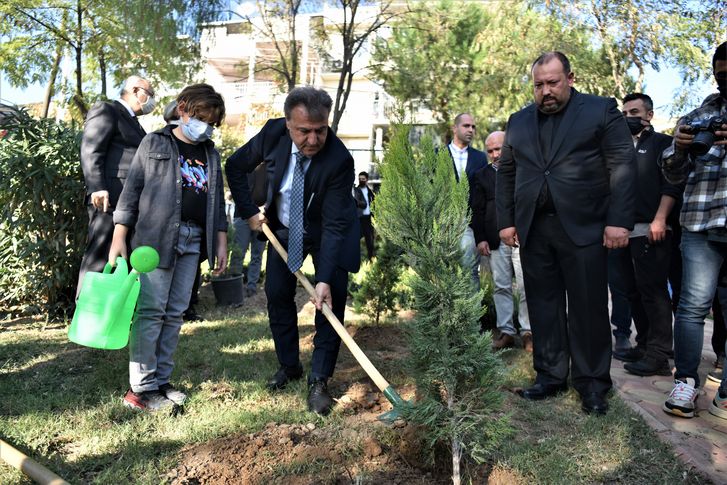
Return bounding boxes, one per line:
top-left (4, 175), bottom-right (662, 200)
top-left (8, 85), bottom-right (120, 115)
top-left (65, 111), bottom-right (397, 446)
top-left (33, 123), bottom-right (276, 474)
top-left (76, 76), bottom-right (155, 296)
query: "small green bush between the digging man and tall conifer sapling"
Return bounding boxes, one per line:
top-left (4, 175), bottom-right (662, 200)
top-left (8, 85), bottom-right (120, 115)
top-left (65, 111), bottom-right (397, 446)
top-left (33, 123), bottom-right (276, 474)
top-left (353, 239), bottom-right (403, 325)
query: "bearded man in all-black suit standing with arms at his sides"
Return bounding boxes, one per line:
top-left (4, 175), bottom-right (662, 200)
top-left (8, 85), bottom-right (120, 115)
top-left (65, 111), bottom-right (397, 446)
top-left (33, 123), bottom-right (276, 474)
top-left (496, 52), bottom-right (636, 414)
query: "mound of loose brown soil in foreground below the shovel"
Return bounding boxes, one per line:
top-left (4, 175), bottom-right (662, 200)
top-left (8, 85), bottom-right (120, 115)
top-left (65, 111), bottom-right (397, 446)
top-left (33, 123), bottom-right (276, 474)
top-left (167, 423), bottom-right (449, 485)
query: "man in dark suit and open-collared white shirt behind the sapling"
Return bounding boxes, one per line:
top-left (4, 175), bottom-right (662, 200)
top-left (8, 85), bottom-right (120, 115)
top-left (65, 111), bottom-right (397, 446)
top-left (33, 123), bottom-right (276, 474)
top-left (447, 113), bottom-right (487, 288)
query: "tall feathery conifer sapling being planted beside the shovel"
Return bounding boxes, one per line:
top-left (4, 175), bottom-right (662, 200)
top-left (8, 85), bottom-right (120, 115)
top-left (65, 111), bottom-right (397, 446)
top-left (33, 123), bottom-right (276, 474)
top-left (376, 127), bottom-right (510, 484)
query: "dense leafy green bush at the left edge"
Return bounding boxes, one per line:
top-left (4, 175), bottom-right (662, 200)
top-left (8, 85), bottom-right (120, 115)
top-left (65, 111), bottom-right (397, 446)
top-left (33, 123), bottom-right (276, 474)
top-left (0, 109), bottom-right (88, 318)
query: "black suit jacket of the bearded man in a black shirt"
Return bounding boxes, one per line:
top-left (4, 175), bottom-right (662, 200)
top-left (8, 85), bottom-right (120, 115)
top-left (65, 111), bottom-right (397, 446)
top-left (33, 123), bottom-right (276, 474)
top-left (496, 89), bottom-right (636, 246)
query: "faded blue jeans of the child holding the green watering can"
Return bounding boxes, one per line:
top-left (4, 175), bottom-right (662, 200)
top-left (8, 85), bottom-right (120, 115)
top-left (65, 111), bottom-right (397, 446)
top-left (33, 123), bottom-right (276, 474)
top-left (129, 223), bottom-right (202, 392)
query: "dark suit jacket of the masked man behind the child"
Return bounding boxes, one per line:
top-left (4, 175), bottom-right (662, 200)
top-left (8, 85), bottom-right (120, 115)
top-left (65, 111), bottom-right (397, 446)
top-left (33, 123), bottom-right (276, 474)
top-left (81, 101), bottom-right (146, 207)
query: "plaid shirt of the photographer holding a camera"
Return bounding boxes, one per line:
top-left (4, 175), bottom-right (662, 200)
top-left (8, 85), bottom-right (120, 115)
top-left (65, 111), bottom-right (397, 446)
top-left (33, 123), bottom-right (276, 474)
top-left (662, 94), bottom-right (727, 232)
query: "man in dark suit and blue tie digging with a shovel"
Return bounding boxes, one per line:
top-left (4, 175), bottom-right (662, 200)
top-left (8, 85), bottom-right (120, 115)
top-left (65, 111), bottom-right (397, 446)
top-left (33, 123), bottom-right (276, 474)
top-left (226, 86), bottom-right (361, 414)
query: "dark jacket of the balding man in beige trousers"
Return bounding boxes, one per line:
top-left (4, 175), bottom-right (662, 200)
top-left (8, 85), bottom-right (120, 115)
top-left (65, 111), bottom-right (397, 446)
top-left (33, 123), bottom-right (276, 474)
top-left (470, 165), bottom-right (500, 250)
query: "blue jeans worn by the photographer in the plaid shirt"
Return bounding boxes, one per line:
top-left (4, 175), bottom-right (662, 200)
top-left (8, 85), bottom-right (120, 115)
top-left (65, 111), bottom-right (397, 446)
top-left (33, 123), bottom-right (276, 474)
top-left (674, 230), bottom-right (727, 389)
